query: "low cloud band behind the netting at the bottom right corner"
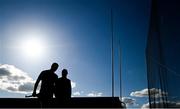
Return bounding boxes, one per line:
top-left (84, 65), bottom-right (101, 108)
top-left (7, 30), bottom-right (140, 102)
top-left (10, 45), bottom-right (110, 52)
top-left (141, 101), bottom-right (180, 109)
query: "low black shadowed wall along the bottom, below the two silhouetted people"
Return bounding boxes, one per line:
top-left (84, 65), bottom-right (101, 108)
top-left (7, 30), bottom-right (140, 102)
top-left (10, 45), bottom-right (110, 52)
top-left (0, 97), bottom-right (123, 108)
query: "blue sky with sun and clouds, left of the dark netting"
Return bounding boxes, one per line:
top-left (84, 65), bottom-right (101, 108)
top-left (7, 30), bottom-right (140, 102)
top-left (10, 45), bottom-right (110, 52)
top-left (0, 0), bottom-right (153, 107)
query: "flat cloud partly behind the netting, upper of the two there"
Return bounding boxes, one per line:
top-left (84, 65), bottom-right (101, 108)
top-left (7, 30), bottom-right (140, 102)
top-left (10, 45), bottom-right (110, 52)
top-left (130, 88), bottom-right (167, 98)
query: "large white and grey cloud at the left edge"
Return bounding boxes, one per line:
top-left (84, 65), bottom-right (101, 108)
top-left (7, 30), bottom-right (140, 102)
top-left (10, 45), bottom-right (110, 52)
top-left (0, 64), bottom-right (34, 93)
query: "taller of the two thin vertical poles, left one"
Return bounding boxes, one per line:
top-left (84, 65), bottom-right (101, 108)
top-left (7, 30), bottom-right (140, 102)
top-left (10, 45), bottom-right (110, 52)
top-left (111, 8), bottom-right (114, 97)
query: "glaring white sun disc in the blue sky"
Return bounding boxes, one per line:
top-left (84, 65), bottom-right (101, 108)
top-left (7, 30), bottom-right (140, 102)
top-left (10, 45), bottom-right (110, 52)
top-left (21, 38), bottom-right (45, 58)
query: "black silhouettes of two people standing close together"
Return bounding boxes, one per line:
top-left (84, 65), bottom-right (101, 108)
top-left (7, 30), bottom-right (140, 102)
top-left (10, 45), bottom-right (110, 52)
top-left (32, 63), bottom-right (71, 106)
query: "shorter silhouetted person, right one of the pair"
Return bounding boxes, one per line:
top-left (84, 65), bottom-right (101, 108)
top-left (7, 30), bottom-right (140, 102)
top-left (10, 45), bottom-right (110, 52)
top-left (55, 69), bottom-right (72, 103)
